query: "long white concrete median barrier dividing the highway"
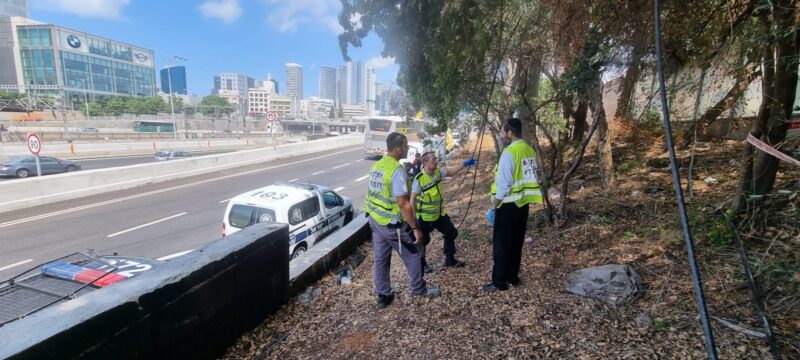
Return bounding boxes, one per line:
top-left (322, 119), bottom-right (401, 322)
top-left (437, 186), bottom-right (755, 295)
top-left (0, 135), bottom-right (363, 213)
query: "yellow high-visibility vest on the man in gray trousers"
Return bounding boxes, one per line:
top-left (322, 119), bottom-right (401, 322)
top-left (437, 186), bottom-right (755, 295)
top-left (364, 156), bottom-right (403, 225)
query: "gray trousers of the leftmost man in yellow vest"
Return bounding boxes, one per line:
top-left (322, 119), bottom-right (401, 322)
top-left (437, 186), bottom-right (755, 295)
top-left (368, 216), bottom-right (426, 296)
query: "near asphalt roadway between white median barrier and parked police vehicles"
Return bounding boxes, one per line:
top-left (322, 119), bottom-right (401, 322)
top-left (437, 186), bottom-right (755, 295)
top-left (0, 146), bottom-right (375, 281)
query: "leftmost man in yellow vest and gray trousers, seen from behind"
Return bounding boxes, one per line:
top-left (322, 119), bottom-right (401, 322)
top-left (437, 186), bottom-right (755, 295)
top-left (364, 132), bottom-right (441, 309)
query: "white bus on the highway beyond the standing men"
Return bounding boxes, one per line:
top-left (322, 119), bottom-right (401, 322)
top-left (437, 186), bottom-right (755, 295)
top-left (364, 116), bottom-right (425, 156)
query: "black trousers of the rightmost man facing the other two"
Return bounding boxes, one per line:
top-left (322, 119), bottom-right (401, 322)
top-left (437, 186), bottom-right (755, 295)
top-left (492, 203), bottom-right (528, 289)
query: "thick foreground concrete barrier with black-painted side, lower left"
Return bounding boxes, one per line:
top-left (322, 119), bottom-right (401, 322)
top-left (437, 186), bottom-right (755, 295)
top-left (0, 223), bottom-right (289, 359)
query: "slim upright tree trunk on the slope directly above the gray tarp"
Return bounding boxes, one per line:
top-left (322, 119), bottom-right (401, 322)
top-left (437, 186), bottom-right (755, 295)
top-left (587, 72), bottom-right (614, 191)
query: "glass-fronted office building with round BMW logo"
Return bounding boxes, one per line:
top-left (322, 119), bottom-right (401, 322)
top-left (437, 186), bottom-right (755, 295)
top-left (0, 16), bottom-right (157, 103)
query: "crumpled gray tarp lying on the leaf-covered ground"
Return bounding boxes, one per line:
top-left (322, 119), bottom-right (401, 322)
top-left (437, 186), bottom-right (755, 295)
top-left (566, 264), bottom-right (642, 306)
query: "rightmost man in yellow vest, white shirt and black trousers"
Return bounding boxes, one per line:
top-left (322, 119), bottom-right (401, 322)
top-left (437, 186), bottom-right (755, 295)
top-left (483, 118), bottom-right (542, 292)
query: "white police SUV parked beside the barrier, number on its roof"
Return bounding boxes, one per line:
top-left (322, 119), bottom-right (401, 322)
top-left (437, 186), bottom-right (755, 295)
top-left (222, 182), bottom-right (353, 259)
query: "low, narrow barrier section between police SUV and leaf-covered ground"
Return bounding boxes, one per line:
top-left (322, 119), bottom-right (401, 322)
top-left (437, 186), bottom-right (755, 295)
top-left (288, 213), bottom-right (372, 297)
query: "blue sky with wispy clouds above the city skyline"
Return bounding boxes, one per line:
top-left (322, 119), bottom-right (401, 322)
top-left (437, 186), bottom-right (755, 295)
top-left (29, 0), bottom-right (397, 96)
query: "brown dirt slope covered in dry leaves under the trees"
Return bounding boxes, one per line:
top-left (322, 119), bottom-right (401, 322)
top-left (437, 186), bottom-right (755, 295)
top-left (225, 124), bottom-right (800, 359)
